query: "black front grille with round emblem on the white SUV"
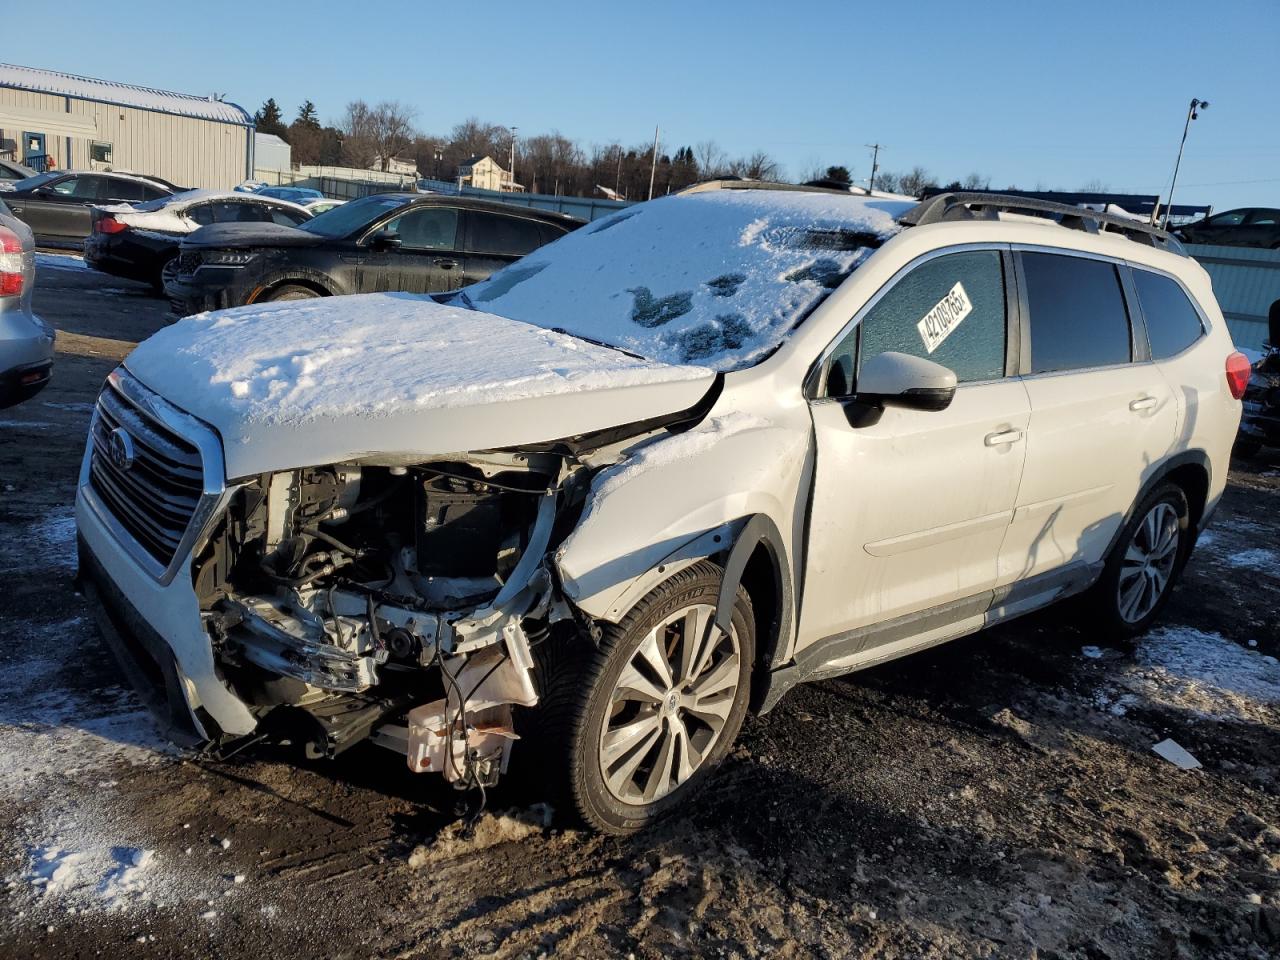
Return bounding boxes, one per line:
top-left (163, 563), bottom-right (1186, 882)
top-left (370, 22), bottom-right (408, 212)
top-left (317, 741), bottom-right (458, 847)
top-left (88, 383), bottom-right (205, 567)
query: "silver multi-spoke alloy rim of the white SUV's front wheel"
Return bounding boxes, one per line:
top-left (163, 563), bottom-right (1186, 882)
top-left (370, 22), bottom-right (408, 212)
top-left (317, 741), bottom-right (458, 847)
top-left (599, 604), bottom-right (741, 804)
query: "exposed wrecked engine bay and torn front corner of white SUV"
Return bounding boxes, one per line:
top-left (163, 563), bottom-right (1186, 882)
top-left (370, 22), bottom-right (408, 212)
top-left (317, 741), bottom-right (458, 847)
top-left (192, 452), bottom-right (593, 787)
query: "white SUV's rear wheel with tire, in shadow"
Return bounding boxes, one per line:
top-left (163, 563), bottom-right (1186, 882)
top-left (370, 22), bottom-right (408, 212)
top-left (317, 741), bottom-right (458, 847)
top-left (1089, 484), bottom-right (1192, 640)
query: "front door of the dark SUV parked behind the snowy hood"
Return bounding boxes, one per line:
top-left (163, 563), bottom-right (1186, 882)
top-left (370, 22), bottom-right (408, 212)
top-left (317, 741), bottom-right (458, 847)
top-left (358, 206), bottom-right (462, 293)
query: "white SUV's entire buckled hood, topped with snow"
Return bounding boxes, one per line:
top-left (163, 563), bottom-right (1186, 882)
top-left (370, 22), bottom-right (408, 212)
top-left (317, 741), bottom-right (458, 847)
top-left (124, 293), bottom-right (716, 479)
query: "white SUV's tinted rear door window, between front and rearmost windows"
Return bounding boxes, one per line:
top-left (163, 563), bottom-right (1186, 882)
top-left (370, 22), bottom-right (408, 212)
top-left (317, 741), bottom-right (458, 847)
top-left (1020, 253), bottom-right (1133, 374)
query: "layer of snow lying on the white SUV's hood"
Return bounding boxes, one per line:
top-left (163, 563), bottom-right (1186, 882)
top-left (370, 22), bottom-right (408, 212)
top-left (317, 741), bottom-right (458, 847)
top-left (125, 293), bottom-right (708, 425)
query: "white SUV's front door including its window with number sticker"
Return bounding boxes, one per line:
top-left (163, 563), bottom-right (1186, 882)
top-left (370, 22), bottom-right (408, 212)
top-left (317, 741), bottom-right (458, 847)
top-left (800, 248), bottom-right (1030, 655)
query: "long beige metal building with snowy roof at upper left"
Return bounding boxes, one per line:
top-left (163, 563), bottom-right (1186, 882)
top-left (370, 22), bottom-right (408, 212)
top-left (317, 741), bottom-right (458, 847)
top-left (0, 64), bottom-right (253, 188)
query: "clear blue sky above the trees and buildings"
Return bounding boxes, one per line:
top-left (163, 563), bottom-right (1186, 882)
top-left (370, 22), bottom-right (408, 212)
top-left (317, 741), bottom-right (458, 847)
top-left (0, 0), bottom-right (1280, 210)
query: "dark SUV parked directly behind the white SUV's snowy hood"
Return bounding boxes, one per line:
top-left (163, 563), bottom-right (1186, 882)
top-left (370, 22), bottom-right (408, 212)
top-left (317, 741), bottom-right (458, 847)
top-left (165, 193), bottom-right (581, 315)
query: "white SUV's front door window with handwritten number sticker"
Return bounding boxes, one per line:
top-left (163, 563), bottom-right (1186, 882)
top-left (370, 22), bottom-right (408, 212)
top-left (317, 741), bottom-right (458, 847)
top-left (826, 250), bottom-right (1009, 397)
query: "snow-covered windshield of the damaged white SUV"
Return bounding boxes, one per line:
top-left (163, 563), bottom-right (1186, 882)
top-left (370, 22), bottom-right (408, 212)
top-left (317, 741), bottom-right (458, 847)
top-left (460, 189), bottom-right (910, 370)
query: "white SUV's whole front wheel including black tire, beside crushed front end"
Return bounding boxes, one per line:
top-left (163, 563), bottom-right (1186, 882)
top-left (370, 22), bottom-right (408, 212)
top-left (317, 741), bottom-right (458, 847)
top-left (522, 561), bottom-right (755, 835)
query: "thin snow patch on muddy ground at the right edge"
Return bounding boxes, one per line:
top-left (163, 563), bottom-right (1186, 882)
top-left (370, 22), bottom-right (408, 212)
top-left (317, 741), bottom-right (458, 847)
top-left (1116, 627), bottom-right (1280, 723)
